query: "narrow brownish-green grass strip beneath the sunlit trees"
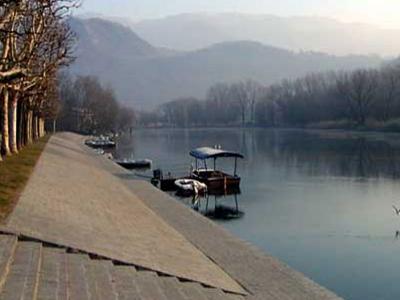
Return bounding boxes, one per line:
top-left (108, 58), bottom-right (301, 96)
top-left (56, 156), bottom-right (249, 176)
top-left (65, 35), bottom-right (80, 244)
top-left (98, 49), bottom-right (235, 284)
top-left (0, 136), bottom-right (50, 223)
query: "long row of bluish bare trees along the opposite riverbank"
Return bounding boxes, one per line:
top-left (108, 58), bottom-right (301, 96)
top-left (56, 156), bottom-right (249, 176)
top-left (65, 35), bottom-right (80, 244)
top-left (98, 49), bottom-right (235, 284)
top-left (152, 64), bottom-right (400, 127)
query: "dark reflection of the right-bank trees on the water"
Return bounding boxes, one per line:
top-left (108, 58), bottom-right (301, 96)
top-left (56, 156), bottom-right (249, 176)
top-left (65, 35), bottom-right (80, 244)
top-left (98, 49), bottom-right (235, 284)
top-left (255, 131), bottom-right (400, 178)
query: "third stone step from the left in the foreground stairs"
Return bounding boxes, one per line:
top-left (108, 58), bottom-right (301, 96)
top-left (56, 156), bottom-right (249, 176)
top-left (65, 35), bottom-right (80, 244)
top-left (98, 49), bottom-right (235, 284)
top-left (38, 247), bottom-right (67, 300)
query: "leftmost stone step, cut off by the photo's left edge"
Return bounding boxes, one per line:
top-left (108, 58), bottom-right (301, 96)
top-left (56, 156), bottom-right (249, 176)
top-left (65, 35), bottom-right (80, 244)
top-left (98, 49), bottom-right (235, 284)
top-left (0, 235), bottom-right (18, 290)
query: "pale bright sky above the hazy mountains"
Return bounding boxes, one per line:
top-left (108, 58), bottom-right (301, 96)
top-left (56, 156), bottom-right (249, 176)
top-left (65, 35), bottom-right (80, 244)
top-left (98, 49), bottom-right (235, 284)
top-left (79, 0), bottom-right (400, 28)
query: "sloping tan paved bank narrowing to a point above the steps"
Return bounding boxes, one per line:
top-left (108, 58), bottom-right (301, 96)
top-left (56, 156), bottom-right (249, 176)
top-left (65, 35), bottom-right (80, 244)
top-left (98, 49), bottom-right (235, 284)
top-left (6, 134), bottom-right (246, 294)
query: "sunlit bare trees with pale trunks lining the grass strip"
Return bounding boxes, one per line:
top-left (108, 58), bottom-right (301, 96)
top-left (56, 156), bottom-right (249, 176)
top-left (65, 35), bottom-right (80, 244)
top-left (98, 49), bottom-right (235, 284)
top-left (0, 0), bottom-right (78, 159)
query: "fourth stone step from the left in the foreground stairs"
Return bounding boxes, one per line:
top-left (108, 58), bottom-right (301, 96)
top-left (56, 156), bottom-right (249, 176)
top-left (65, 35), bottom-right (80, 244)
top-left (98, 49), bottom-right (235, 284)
top-left (65, 253), bottom-right (91, 300)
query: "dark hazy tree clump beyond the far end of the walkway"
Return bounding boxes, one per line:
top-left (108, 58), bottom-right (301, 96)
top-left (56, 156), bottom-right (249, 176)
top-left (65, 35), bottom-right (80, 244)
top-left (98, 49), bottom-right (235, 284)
top-left (57, 73), bottom-right (135, 134)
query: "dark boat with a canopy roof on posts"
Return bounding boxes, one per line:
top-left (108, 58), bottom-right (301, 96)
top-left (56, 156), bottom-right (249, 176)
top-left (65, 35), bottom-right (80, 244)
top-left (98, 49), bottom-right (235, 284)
top-left (190, 147), bottom-right (244, 190)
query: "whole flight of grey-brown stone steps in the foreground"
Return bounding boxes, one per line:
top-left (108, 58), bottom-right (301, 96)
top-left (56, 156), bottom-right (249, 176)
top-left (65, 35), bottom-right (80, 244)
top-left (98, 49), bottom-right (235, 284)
top-left (0, 233), bottom-right (244, 300)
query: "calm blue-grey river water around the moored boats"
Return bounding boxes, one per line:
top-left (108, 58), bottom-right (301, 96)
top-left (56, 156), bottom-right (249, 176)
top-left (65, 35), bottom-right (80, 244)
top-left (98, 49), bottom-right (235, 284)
top-left (113, 129), bottom-right (400, 300)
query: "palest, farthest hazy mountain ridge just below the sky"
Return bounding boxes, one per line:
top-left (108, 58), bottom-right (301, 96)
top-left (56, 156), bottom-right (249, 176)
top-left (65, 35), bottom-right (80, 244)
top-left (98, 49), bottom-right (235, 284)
top-left (132, 13), bottom-right (400, 56)
